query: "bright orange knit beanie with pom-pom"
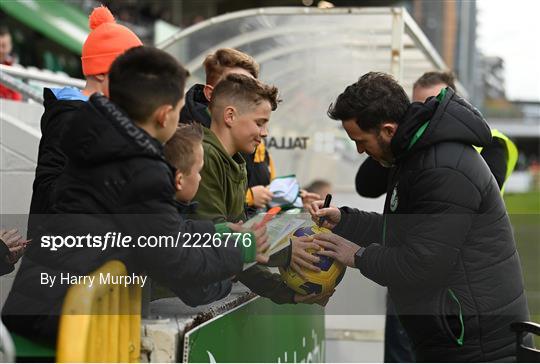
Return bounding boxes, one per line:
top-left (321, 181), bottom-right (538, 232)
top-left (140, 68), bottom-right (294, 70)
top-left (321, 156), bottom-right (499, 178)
top-left (81, 6), bottom-right (142, 76)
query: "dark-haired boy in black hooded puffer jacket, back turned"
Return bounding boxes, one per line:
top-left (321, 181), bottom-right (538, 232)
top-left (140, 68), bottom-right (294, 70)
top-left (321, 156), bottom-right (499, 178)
top-left (2, 47), bottom-right (267, 341)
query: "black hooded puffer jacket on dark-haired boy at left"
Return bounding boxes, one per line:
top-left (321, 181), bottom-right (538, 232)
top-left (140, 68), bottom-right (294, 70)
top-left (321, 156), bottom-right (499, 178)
top-left (2, 95), bottom-right (243, 340)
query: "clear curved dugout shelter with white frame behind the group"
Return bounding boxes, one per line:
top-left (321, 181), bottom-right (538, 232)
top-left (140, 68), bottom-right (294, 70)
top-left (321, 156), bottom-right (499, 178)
top-left (157, 7), bottom-right (465, 190)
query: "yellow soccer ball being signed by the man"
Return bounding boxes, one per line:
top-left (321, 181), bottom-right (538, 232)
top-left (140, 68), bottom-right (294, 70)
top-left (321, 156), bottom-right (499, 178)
top-left (279, 225), bottom-right (345, 295)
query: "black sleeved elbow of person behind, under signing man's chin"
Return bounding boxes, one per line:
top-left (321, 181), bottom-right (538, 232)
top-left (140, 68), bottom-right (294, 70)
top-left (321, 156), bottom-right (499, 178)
top-left (355, 157), bottom-right (390, 198)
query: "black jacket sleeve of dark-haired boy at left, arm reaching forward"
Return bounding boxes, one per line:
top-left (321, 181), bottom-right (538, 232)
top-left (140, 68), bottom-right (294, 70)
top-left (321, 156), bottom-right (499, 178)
top-left (120, 165), bottom-right (243, 300)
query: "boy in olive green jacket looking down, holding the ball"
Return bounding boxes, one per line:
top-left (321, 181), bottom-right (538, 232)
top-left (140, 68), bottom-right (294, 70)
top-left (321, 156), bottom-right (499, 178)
top-left (195, 73), bottom-right (324, 304)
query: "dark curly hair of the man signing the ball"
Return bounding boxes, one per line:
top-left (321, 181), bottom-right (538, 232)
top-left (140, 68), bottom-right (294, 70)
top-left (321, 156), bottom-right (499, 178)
top-left (328, 72), bottom-right (410, 131)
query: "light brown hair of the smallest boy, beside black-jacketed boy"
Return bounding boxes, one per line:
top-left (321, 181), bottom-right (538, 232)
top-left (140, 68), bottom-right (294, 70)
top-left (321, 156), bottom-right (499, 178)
top-left (163, 123), bottom-right (203, 175)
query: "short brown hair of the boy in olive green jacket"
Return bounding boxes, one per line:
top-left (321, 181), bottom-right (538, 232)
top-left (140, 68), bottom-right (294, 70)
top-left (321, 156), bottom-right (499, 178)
top-left (209, 73), bottom-right (280, 111)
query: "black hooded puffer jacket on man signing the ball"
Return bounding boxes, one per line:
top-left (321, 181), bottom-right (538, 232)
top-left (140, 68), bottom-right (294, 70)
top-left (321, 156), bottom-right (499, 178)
top-left (334, 89), bottom-right (530, 362)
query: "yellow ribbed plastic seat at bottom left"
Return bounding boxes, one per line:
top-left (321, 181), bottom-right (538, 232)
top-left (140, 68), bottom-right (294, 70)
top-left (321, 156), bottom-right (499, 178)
top-left (56, 260), bottom-right (141, 362)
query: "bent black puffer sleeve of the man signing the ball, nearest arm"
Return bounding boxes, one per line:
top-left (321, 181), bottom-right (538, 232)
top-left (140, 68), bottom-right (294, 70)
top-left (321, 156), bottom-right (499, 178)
top-left (359, 168), bottom-right (482, 287)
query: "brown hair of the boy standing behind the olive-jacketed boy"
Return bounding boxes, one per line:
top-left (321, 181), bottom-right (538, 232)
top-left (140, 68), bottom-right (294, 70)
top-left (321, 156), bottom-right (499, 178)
top-left (203, 48), bottom-right (259, 86)
